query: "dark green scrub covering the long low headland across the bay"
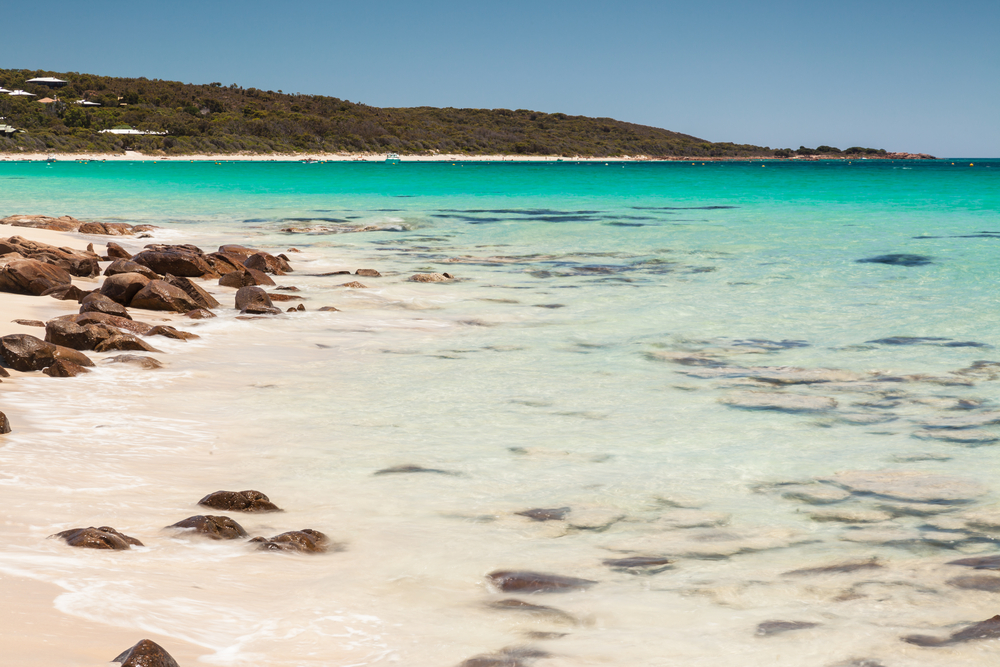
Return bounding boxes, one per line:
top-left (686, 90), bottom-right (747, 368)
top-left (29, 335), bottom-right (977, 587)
top-left (0, 69), bottom-right (885, 158)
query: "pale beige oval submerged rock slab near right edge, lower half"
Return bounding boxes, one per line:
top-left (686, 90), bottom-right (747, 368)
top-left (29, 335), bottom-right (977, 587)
top-left (824, 470), bottom-right (987, 503)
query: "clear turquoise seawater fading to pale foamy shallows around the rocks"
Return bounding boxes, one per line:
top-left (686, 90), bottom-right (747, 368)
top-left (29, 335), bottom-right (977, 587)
top-left (0, 160), bottom-right (1000, 667)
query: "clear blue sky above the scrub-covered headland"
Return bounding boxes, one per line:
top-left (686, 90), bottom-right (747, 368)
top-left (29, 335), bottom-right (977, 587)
top-left (0, 0), bottom-right (1000, 157)
